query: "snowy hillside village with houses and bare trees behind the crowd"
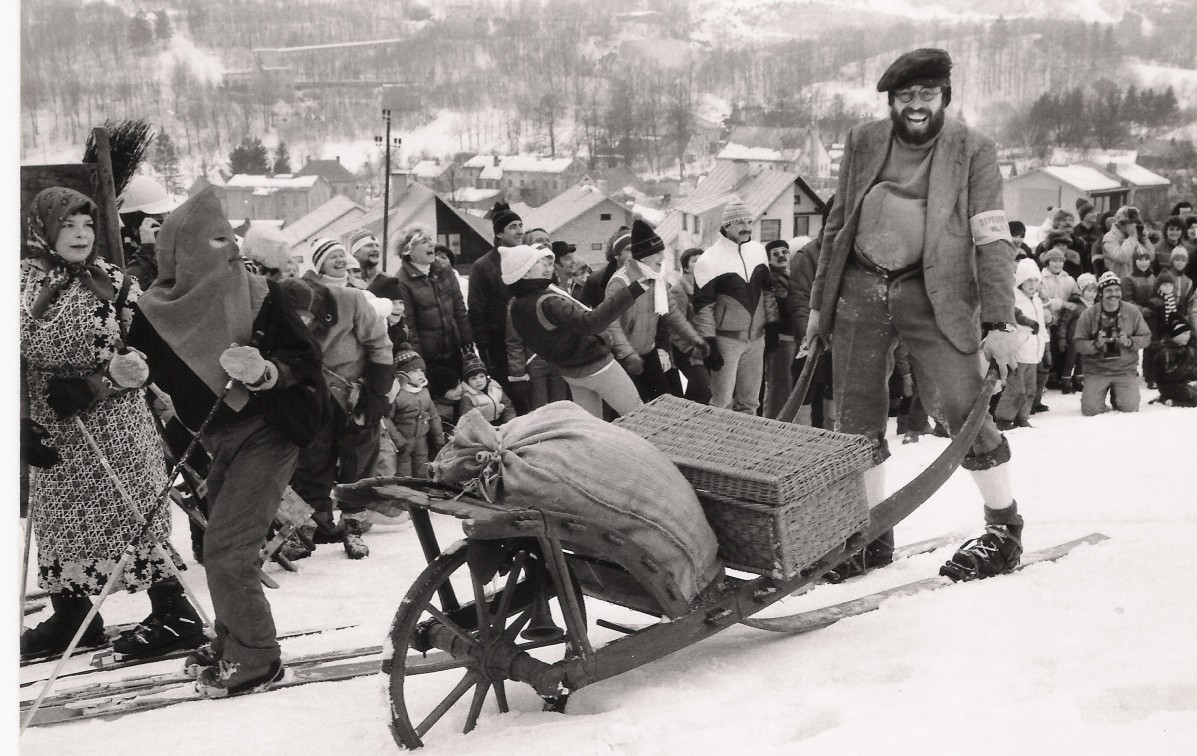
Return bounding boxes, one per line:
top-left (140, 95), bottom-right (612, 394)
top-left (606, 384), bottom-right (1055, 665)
top-left (20, 0), bottom-right (1197, 270)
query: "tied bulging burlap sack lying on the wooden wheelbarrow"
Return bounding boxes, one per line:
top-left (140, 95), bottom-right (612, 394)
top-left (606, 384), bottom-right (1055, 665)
top-left (431, 402), bottom-right (719, 600)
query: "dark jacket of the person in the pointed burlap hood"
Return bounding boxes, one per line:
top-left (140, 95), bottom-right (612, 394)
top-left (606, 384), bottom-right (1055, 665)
top-left (128, 281), bottom-right (330, 446)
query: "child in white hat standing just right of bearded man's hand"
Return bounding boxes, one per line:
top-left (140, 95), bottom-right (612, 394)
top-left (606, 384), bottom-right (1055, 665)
top-left (994, 257), bottom-right (1047, 431)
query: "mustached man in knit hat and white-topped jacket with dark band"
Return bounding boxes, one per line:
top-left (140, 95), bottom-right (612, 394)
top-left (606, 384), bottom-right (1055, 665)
top-left (693, 199), bottom-right (778, 415)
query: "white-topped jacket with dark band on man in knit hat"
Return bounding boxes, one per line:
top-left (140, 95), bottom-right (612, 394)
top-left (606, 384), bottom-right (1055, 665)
top-left (693, 234), bottom-right (778, 341)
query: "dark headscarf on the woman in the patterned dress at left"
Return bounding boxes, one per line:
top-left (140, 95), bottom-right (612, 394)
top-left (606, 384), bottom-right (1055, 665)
top-left (22, 187), bottom-right (116, 319)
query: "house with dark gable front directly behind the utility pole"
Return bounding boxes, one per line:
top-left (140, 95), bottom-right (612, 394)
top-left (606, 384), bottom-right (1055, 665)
top-left (324, 173), bottom-right (494, 272)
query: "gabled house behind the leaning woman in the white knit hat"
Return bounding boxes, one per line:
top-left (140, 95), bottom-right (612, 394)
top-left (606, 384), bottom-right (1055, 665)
top-left (524, 182), bottom-right (632, 268)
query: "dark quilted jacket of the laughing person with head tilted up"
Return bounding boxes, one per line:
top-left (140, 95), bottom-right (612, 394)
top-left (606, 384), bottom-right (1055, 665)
top-left (395, 260), bottom-right (471, 361)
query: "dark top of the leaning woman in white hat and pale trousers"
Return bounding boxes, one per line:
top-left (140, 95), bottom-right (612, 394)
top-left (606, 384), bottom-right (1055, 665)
top-left (511, 279), bottom-right (644, 378)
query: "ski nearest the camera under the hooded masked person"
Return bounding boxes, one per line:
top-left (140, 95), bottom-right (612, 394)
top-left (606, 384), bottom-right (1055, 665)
top-left (30, 647), bottom-right (382, 727)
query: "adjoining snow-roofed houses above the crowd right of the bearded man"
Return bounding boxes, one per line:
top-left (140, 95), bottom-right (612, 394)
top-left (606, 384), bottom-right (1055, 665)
top-left (1002, 163), bottom-right (1171, 226)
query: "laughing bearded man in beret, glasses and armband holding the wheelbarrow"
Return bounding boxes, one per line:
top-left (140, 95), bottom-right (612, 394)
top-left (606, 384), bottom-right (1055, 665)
top-left (803, 49), bottom-right (1022, 580)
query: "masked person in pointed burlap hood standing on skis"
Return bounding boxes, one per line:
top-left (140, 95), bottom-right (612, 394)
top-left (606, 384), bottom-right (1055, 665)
top-left (129, 189), bottom-right (328, 696)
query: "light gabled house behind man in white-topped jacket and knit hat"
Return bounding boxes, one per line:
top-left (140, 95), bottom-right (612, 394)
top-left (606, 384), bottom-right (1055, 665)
top-left (657, 160), bottom-right (825, 250)
